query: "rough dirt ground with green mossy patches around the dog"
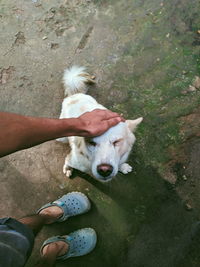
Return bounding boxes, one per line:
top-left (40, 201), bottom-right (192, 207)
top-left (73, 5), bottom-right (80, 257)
top-left (0, 0), bottom-right (200, 267)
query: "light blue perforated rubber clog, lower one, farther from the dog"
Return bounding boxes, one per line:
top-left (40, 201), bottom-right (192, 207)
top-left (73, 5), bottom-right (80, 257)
top-left (40, 228), bottom-right (97, 260)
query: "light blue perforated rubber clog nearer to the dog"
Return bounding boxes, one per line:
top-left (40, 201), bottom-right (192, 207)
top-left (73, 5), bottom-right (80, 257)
top-left (37, 192), bottom-right (90, 222)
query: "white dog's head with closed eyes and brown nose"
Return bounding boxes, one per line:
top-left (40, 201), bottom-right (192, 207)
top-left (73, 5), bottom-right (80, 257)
top-left (86, 118), bottom-right (143, 182)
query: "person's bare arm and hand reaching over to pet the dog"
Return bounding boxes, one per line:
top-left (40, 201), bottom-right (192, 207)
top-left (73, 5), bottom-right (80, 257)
top-left (0, 109), bottom-right (124, 157)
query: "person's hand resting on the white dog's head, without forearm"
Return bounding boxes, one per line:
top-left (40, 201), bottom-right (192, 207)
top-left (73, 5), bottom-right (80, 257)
top-left (75, 109), bottom-right (125, 137)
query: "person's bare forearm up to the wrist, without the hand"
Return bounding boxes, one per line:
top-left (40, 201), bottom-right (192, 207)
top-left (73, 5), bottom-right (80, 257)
top-left (0, 112), bottom-right (77, 156)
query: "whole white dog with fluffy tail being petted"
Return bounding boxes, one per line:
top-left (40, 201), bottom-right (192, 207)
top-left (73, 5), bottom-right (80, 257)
top-left (58, 66), bottom-right (143, 182)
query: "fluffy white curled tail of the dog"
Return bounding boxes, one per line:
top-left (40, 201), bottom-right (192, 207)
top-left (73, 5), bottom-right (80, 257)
top-left (63, 66), bottom-right (95, 96)
